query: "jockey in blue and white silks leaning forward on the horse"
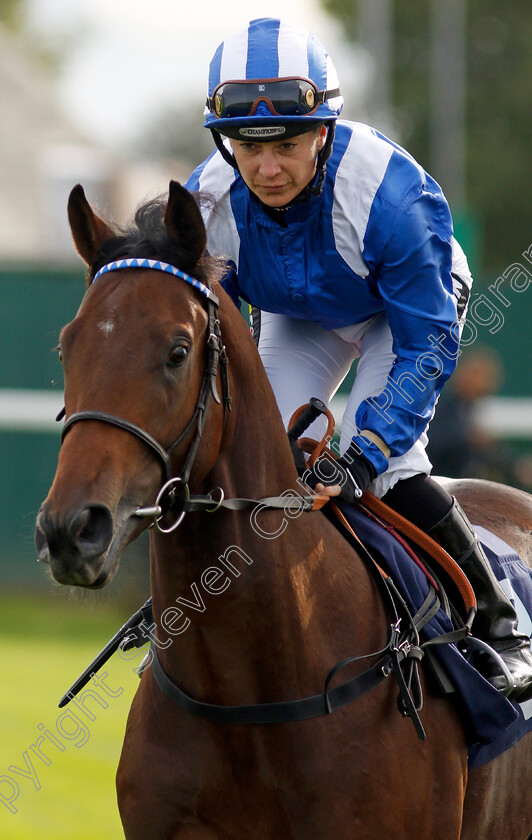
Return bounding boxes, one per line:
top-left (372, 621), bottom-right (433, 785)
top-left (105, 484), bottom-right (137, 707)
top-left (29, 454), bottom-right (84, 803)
top-left (186, 18), bottom-right (532, 702)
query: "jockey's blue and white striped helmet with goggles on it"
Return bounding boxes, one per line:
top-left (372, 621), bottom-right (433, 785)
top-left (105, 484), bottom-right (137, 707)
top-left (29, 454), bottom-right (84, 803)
top-left (204, 18), bottom-right (344, 140)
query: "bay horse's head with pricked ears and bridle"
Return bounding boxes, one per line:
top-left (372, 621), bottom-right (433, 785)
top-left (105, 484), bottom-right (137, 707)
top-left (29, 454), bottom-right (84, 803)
top-left (36, 182), bottom-right (231, 588)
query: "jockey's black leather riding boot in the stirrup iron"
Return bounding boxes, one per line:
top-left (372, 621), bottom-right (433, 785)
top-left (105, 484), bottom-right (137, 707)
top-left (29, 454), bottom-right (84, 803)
top-left (428, 499), bottom-right (532, 703)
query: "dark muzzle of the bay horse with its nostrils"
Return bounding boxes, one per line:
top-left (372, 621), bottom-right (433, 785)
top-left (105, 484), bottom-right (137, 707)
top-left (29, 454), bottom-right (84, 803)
top-left (35, 503), bottom-right (113, 588)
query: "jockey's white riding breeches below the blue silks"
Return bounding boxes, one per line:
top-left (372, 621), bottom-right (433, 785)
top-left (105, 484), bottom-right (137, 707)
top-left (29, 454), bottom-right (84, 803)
top-left (258, 312), bottom-right (432, 498)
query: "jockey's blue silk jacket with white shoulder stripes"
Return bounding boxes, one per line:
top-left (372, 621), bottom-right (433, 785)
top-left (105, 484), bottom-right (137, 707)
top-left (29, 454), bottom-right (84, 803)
top-left (186, 121), bottom-right (471, 474)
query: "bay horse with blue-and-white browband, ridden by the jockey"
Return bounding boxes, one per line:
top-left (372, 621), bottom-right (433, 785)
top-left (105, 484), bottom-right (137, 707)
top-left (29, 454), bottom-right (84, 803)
top-left (36, 182), bottom-right (532, 840)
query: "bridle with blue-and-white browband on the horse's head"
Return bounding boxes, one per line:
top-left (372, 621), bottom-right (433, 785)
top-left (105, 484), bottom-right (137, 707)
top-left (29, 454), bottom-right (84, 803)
top-left (57, 258), bottom-right (231, 533)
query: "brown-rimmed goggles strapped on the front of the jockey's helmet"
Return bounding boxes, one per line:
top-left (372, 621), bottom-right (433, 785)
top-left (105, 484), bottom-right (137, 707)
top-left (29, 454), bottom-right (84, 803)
top-left (207, 76), bottom-right (340, 119)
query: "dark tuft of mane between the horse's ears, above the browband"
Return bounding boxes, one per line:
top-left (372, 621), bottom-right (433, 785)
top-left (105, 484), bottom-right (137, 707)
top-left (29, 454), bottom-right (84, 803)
top-left (87, 194), bottom-right (227, 285)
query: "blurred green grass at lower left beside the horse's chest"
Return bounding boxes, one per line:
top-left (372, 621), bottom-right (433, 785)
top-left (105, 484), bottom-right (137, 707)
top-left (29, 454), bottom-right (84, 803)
top-left (0, 588), bottom-right (150, 840)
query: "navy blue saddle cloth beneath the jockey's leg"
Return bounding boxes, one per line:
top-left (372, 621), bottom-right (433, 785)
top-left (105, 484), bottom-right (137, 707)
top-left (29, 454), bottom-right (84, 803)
top-left (339, 504), bottom-right (532, 768)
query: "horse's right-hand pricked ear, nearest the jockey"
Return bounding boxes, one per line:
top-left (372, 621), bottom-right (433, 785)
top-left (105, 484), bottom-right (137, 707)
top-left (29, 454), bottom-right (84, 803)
top-left (164, 181), bottom-right (207, 267)
